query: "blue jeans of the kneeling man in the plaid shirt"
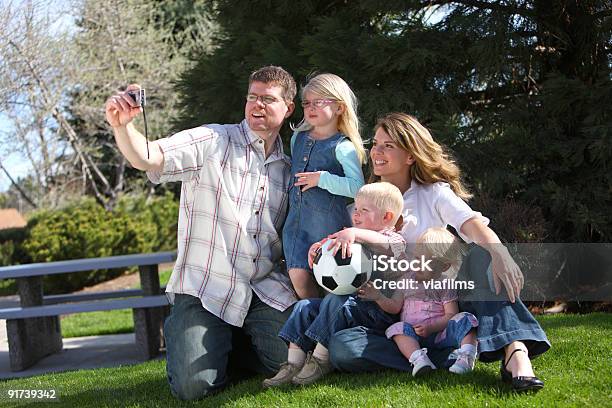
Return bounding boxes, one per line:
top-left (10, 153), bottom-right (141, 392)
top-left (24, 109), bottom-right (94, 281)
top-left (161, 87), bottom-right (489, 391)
top-left (164, 294), bottom-right (291, 400)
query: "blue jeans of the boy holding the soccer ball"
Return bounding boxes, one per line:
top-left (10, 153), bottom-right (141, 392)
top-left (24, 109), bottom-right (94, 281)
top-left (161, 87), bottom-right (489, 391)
top-left (278, 293), bottom-right (396, 351)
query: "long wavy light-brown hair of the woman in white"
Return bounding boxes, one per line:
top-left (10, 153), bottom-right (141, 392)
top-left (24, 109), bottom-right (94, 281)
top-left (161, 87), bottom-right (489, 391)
top-left (374, 112), bottom-right (472, 200)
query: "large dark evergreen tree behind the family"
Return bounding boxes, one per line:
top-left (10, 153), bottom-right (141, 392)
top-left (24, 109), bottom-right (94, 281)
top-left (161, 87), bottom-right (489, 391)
top-left (177, 0), bottom-right (612, 242)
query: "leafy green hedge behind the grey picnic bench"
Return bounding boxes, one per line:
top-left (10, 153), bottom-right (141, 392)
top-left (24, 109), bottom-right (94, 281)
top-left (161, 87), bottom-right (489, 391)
top-left (23, 195), bottom-right (178, 293)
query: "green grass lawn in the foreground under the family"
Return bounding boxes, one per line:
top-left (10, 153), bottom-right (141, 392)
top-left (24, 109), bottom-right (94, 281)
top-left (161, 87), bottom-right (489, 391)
top-left (0, 313), bottom-right (612, 407)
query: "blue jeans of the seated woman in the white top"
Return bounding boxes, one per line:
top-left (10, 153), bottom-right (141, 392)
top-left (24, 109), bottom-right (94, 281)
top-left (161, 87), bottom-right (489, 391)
top-left (328, 247), bottom-right (550, 372)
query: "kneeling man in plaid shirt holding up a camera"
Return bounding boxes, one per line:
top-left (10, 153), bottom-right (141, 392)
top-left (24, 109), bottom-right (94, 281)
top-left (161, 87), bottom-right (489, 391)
top-left (106, 66), bottom-right (296, 400)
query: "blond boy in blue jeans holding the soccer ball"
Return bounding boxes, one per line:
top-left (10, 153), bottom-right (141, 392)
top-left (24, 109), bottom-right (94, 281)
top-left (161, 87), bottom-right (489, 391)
top-left (263, 182), bottom-right (405, 387)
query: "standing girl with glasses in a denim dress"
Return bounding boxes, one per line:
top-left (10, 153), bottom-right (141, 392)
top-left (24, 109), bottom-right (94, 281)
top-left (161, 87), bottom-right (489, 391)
top-left (283, 74), bottom-right (366, 299)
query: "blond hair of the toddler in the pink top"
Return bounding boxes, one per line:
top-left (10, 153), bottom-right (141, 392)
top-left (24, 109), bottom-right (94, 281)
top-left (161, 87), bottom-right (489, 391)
top-left (417, 227), bottom-right (465, 279)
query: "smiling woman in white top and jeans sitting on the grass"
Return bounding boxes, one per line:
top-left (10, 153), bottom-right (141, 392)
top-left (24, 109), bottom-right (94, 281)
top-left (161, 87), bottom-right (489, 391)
top-left (329, 113), bottom-right (550, 391)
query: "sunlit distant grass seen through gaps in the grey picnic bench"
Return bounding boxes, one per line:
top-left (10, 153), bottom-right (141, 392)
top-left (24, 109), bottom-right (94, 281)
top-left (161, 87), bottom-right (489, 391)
top-left (60, 269), bottom-right (172, 338)
